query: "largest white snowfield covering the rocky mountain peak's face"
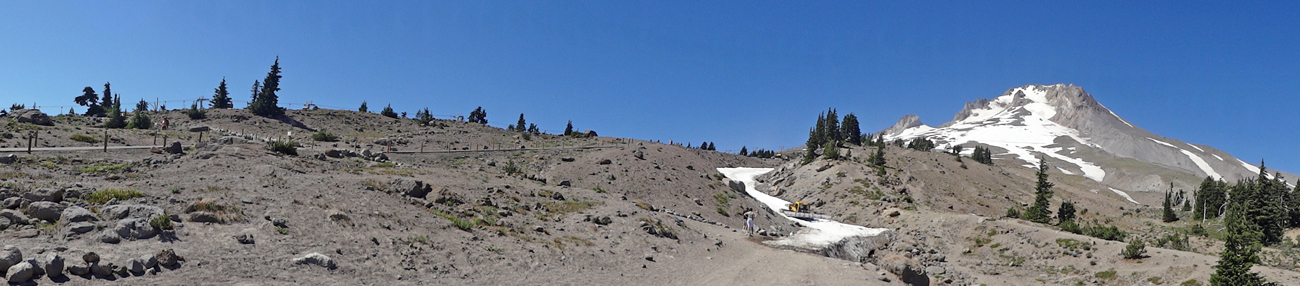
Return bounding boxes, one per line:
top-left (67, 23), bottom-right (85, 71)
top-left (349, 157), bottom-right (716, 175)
top-left (887, 87), bottom-right (1107, 182)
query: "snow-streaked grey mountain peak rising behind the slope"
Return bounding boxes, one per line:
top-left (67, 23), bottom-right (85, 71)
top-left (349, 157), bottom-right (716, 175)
top-left (880, 83), bottom-right (1295, 191)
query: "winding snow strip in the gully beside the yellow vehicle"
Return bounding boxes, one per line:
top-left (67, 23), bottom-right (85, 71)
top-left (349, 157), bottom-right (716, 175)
top-left (718, 168), bottom-right (889, 248)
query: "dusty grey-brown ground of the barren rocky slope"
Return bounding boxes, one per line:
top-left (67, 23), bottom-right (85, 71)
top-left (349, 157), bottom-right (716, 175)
top-left (0, 111), bottom-right (1300, 285)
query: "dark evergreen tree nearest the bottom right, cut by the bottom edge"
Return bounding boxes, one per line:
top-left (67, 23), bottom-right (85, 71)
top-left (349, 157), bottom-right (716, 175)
top-left (1210, 202), bottom-right (1265, 286)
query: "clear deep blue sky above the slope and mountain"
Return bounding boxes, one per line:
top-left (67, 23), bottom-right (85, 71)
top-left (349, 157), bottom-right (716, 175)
top-left (0, 1), bottom-right (1300, 172)
